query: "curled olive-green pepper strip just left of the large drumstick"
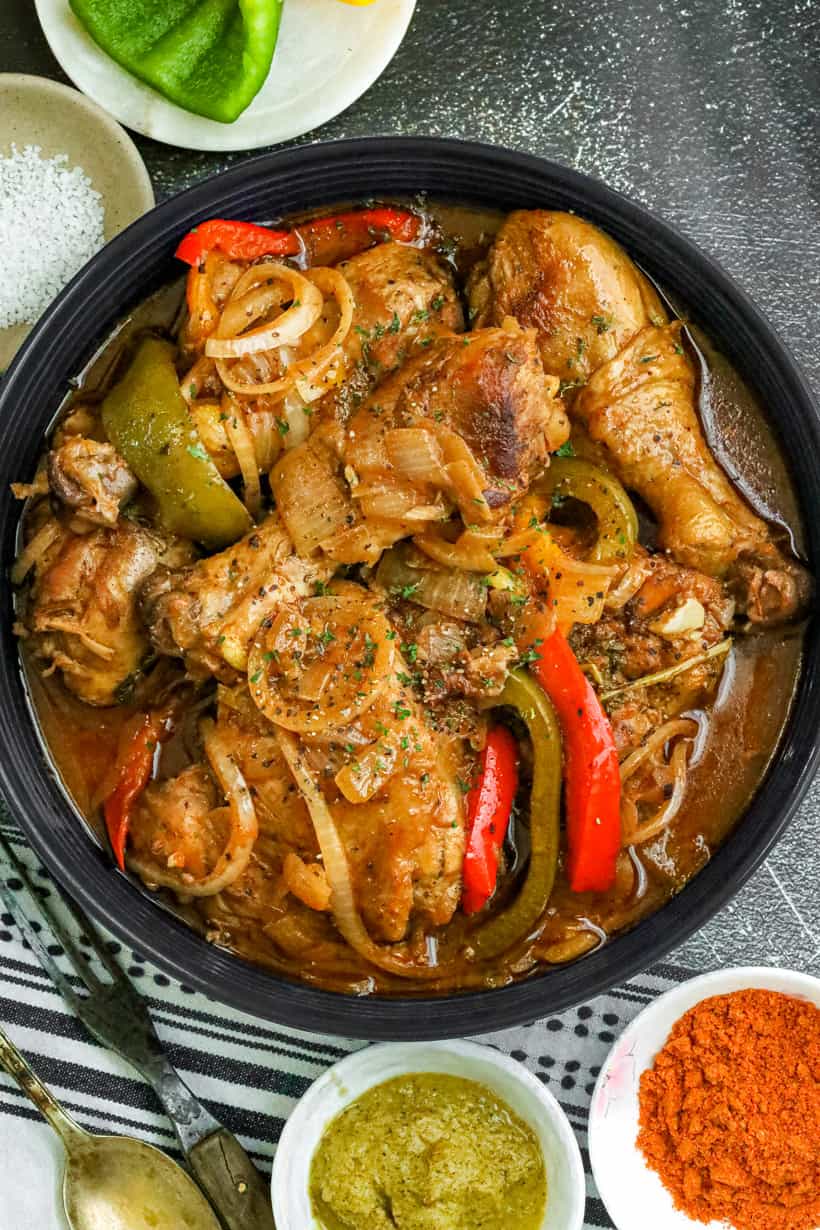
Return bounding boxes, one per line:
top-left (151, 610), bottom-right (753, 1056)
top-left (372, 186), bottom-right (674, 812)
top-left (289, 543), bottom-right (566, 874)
top-left (535, 456), bottom-right (638, 563)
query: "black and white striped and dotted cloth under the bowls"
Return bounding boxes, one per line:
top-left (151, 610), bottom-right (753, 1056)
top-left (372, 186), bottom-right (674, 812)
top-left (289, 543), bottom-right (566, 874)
top-left (0, 822), bottom-right (692, 1230)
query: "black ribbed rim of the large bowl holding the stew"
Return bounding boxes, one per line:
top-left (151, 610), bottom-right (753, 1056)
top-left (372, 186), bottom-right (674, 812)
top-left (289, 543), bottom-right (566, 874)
top-left (0, 137), bottom-right (820, 1039)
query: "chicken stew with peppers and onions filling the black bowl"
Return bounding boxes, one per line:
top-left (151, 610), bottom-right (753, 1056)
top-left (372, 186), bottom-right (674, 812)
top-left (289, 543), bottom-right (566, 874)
top-left (12, 204), bottom-right (811, 994)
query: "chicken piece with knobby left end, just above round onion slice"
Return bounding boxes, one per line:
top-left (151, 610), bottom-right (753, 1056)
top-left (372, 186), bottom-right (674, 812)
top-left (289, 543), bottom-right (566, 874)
top-left (141, 513), bottom-right (329, 683)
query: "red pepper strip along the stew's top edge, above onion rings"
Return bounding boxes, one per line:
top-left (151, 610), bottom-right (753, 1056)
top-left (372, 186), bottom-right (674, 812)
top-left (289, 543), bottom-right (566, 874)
top-left (176, 205), bottom-right (423, 266)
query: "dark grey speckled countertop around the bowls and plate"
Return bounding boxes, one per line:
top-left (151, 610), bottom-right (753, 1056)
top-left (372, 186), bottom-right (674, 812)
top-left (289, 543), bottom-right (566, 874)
top-left (0, 0), bottom-right (820, 973)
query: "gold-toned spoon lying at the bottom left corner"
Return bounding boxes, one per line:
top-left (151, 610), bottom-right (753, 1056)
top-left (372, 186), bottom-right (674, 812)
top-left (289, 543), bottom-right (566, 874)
top-left (0, 1028), bottom-right (220, 1230)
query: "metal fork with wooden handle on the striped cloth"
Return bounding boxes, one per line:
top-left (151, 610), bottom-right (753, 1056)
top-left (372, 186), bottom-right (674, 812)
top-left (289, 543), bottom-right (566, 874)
top-left (0, 834), bottom-right (275, 1230)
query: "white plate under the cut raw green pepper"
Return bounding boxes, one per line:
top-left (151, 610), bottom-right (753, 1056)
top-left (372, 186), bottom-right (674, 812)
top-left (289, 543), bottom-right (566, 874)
top-left (36, 0), bottom-right (416, 150)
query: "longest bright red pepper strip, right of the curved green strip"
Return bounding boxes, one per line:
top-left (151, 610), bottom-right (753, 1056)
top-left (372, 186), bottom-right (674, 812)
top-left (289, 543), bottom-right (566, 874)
top-left (530, 619), bottom-right (621, 893)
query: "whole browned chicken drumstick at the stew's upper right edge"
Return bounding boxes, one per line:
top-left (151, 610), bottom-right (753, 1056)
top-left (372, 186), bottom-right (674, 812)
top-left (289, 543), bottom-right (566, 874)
top-left (470, 210), bottom-right (809, 624)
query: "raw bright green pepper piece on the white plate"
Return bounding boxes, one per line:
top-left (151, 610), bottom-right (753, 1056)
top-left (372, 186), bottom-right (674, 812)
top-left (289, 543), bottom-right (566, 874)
top-left (70, 0), bottom-right (282, 124)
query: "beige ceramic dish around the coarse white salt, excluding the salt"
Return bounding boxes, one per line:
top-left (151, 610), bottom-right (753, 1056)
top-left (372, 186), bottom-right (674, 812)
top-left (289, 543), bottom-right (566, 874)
top-left (0, 73), bottom-right (154, 373)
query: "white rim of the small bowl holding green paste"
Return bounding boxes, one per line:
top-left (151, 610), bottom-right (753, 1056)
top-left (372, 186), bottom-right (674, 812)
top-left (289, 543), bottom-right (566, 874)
top-left (270, 1038), bottom-right (586, 1230)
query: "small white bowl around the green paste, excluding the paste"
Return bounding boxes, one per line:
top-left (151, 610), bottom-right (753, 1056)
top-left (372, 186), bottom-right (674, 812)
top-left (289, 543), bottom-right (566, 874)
top-left (272, 1042), bottom-right (586, 1230)
